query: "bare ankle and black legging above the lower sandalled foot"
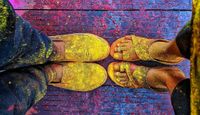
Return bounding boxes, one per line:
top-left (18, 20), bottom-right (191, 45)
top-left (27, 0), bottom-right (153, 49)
top-left (140, 67), bottom-right (190, 115)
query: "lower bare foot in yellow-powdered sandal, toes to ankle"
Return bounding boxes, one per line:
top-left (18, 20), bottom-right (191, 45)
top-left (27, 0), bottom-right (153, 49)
top-left (108, 62), bottom-right (185, 93)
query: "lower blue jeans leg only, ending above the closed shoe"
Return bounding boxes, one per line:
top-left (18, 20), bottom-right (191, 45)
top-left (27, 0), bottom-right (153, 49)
top-left (0, 67), bottom-right (47, 115)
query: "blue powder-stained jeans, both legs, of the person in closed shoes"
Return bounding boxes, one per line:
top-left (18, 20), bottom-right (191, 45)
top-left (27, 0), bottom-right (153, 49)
top-left (0, 0), bottom-right (52, 115)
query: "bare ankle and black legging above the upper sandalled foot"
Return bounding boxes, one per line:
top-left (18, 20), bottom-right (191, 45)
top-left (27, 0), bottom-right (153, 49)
top-left (150, 22), bottom-right (192, 59)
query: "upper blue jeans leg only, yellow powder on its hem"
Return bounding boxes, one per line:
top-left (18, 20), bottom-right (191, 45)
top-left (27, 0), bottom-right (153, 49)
top-left (0, 0), bottom-right (53, 70)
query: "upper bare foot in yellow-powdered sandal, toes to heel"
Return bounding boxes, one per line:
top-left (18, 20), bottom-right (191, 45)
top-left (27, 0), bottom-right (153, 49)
top-left (110, 35), bottom-right (183, 64)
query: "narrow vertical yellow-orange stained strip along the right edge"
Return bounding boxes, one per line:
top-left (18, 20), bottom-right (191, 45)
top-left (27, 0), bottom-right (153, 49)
top-left (191, 0), bottom-right (200, 115)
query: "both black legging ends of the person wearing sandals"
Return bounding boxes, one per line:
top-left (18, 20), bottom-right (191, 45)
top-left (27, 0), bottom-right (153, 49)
top-left (171, 22), bottom-right (192, 115)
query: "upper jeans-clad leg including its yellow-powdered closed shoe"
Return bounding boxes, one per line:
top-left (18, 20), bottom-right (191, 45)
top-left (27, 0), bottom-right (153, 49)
top-left (0, 0), bottom-right (110, 70)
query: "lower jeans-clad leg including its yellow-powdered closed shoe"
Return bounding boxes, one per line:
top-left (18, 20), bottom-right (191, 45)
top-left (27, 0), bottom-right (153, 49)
top-left (0, 62), bottom-right (107, 115)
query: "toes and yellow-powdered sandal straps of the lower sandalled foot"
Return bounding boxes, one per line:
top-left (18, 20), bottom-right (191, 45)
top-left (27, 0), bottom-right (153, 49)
top-left (108, 62), bottom-right (153, 88)
